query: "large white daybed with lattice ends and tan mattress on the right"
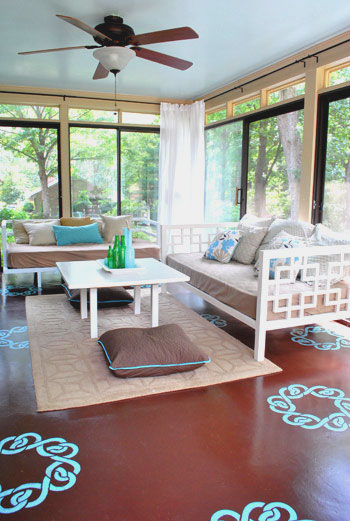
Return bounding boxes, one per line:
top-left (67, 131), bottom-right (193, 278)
top-left (161, 217), bottom-right (350, 361)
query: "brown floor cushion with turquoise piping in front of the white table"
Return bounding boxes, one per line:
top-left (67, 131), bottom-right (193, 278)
top-left (98, 324), bottom-right (210, 378)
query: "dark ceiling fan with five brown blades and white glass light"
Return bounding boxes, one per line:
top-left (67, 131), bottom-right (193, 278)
top-left (18, 14), bottom-right (198, 80)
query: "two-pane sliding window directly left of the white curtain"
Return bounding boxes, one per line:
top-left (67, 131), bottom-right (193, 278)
top-left (70, 125), bottom-right (159, 219)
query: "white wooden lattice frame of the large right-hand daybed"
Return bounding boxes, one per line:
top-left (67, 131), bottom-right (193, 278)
top-left (160, 223), bottom-right (350, 361)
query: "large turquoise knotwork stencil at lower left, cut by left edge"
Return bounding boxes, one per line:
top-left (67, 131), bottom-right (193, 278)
top-left (0, 432), bottom-right (80, 514)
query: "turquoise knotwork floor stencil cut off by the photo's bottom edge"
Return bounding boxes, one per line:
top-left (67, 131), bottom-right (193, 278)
top-left (210, 501), bottom-right (315, 521)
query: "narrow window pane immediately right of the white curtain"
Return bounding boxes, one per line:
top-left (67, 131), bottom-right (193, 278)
top-left (205, 121), bottom-right (243, 222)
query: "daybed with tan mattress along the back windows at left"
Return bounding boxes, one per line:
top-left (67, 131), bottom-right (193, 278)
top-left (2, 218), bottom-right (160, 288)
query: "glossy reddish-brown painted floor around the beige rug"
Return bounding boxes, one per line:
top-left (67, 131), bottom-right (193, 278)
top-left (0, 277), bottom-right (350, 521)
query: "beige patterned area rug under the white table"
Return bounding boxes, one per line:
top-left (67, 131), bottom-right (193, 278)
top-left (26, 290), bottom-right (281, 411)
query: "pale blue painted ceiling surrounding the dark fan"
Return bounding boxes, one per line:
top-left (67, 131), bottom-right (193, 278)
top-left (0, 0), bottom-right (350, 99)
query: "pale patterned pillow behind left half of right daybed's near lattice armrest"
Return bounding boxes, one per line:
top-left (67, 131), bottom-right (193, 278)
top-left (254, 231), bottom-right (305, 282)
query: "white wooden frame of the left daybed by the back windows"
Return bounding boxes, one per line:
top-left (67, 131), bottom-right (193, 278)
top-left (1, 217), bottom-right (160, 289)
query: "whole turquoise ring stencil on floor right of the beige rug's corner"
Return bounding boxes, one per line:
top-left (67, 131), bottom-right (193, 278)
top-left (267, 384), bottom-right (350, 432)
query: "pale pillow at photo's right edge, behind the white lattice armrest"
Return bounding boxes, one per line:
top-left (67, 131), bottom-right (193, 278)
top-left (307, 224), bottom-right (350, 287)
